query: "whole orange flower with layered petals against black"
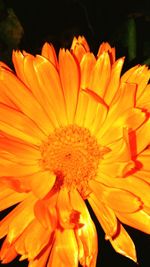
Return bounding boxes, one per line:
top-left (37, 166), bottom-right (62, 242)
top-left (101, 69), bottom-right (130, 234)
top-left (0, 37), bottom-right (150, 267)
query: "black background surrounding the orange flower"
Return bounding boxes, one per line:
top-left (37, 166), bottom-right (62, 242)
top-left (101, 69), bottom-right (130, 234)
top-left (2, 0), bottom-right (150, 267)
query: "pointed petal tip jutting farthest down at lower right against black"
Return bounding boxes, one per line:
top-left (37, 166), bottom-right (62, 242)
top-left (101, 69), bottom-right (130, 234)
top-left (110, 225), bottom-right (137, 262)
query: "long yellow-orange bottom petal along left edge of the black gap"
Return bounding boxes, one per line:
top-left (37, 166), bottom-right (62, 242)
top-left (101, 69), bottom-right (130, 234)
top-left (70, 190), bottom-right (98, 267)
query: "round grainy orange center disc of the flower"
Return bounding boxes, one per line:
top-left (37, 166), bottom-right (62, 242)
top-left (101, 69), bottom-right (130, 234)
top-left (41, 125), bottom-right (108, 198)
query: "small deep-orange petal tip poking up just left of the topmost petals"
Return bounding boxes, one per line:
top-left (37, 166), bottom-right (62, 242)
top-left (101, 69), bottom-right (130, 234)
top-left (41, 42), bottom-right (58, 69)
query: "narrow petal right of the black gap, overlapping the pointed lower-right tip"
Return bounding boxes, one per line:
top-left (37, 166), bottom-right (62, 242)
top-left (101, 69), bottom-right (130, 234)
top-left (88, 193), bottom-right (118, 239)
